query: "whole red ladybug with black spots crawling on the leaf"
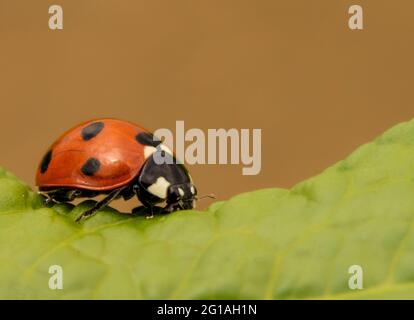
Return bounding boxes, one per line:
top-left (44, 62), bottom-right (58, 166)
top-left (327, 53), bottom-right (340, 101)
top-left (36, 118), bottom-right (197, 221)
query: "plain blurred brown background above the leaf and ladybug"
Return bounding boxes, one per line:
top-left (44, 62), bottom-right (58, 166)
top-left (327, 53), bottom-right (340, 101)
top-left (0, 0), bottom-right (414, 212)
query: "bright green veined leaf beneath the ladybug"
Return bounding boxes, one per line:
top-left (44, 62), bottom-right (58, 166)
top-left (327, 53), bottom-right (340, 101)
top-left (0, 121), bottom-right (414, 299)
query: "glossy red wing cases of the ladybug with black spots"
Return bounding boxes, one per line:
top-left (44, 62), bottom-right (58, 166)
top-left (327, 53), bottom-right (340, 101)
top-left (36, 118), bottom-right (148, 191)
